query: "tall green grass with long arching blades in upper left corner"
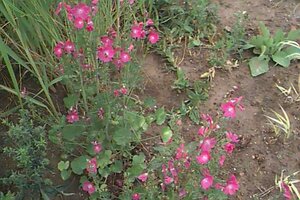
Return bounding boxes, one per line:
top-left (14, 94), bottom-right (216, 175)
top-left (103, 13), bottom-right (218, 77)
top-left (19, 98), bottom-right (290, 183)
top-left (0, 0), bottom-right (64, 117)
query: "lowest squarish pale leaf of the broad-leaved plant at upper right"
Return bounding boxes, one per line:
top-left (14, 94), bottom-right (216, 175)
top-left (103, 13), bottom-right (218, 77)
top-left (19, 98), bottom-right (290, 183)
top-left (249, 56), bottom-right (270, 76)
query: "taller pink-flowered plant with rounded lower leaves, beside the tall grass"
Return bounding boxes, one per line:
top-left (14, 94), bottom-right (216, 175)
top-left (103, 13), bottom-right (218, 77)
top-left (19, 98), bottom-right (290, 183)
top-left (49, 0), bottom-right (160, 199)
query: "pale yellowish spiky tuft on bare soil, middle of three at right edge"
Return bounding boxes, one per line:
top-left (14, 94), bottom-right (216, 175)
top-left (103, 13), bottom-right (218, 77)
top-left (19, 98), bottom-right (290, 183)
top-left (265, 106), bottom-right (292, 138)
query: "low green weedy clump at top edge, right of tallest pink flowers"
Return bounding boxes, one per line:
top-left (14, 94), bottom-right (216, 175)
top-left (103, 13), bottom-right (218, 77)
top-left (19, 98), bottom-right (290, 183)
top-left (153, 0), bottom-right (218, 68)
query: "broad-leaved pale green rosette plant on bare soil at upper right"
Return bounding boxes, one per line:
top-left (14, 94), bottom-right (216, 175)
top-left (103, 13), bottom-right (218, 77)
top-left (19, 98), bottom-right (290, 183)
top-left (244, 23), bottom-right (300, 76)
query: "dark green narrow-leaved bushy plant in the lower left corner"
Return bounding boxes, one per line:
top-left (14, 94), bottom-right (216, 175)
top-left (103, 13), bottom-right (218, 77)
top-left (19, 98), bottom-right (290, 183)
top-left (0, 110), bottom-right (49, 199)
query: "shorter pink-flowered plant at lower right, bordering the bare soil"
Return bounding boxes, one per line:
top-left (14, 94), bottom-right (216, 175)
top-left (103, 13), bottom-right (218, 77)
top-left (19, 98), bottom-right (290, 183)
top-left (121, 97), bottom-right (244, 199)
